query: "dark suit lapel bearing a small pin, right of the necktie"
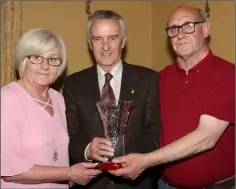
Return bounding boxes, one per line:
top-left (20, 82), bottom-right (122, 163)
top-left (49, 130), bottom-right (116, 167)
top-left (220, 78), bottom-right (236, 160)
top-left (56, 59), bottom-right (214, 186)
top-left (120, 62), bottom-right (138, 101)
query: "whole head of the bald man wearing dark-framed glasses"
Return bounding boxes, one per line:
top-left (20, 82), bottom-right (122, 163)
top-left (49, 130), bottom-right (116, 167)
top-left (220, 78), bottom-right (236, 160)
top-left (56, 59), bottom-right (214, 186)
top-left (166, 6), bottom-right (210, 60)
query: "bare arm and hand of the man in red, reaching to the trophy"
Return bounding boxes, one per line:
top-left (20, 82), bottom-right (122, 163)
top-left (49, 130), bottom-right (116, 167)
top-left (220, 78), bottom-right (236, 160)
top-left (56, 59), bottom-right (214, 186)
top-left (110, 115), bottom-right (229, 179)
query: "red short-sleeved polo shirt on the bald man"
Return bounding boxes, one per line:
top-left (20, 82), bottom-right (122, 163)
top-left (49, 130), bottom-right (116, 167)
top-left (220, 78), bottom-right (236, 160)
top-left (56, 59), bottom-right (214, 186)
top-left (160, 51), bottom-right (235, 189)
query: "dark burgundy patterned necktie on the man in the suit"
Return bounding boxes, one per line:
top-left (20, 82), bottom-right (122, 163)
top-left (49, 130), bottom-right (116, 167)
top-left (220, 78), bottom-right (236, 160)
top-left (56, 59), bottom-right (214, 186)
top-left (101, 73), bottom-right (115, 101)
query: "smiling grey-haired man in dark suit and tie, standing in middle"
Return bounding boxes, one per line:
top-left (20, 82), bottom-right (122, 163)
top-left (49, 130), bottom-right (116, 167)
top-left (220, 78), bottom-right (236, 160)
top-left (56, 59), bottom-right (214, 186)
top-left (63, 10), bottom-right (160, 189)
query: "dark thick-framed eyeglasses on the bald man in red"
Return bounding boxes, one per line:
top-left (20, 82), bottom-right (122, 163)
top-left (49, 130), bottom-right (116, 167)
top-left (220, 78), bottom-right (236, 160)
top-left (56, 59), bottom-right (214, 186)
top-left (166, 20), bottom-right (205, 38)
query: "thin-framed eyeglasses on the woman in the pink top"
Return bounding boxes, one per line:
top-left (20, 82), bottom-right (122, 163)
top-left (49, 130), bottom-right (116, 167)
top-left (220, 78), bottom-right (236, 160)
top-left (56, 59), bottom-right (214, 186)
top-left (27, 55), bottom-right (62, 66)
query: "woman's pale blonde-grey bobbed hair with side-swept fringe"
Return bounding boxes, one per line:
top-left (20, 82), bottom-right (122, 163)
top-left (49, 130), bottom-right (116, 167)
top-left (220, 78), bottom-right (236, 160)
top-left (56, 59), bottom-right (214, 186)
top-left (15, 28), bottom-right (67, 78)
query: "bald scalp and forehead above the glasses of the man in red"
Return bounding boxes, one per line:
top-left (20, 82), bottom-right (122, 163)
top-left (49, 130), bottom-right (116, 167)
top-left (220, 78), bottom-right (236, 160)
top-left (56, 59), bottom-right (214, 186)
top-left (167, 5), bottom-right (205, 27)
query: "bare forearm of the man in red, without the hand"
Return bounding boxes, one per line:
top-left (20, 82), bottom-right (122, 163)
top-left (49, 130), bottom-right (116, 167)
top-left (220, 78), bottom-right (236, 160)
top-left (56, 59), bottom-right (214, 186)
top-left (146, 115), bottom-right (229, 166)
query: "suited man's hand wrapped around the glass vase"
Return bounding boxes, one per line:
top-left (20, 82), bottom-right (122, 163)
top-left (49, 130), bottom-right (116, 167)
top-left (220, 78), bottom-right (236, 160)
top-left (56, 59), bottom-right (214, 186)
top-left (87, 137), bottom-right (114, 162)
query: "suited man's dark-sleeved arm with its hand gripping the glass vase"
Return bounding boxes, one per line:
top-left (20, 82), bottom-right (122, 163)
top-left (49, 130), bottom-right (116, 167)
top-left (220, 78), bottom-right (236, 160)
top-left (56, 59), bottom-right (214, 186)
top-left (63, 78), bottom-right (114, 165)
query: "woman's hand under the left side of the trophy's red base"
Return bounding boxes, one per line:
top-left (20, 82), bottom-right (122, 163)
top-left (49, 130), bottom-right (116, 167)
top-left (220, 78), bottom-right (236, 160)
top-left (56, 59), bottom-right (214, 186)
top-left (71, 162), bottom-right (101, 185)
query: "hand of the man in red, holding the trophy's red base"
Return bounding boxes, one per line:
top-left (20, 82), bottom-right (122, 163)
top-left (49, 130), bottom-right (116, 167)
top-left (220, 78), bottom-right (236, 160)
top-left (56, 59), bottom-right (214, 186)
top-left (109, 153), bottom-right (147, 180)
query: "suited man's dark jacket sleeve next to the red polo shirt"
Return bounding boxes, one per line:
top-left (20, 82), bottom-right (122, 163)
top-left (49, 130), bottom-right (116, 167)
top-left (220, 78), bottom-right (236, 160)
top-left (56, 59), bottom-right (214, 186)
top-left (144, 73), bottom-right (160, 153)
